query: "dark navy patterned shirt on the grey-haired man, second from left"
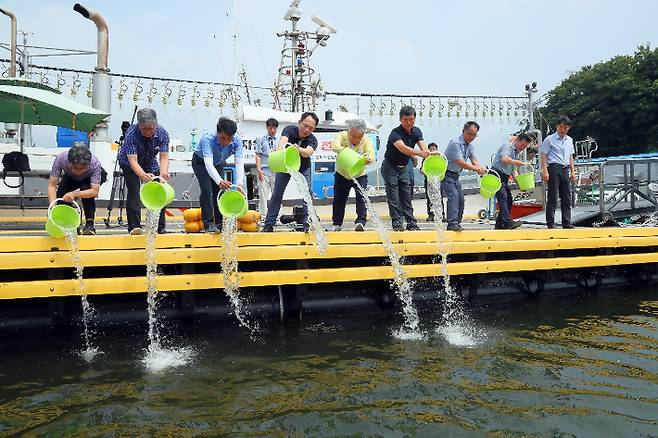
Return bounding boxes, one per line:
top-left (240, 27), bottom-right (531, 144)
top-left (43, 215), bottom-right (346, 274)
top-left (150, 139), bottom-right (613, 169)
top-left (117, 124), bottom-right (169, 173)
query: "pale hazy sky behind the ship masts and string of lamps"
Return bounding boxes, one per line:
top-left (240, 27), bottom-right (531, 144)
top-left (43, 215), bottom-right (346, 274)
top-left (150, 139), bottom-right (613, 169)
top-left (0, 0), bottom-right (658, 161)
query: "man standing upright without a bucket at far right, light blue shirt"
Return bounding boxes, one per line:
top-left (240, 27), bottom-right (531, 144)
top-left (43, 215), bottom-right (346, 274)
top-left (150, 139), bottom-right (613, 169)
top-left (539, 116), bottom-right (576, 229)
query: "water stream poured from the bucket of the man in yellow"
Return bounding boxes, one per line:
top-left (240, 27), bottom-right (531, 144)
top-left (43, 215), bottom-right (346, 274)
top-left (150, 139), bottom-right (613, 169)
top-left (352, 179), bottom-right (422, 339)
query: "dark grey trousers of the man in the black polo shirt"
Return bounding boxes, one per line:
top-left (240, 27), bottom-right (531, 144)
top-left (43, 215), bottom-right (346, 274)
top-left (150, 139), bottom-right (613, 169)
top-left (382, 160), bottom-right (417, 228)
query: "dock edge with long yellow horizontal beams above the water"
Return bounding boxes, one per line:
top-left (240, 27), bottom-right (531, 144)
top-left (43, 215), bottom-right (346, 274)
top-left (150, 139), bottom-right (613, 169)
top-left (0, 228), bottom-right (658, 326)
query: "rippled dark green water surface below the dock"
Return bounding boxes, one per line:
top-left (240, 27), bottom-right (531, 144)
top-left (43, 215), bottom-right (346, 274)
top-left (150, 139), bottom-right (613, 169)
top-left (0, 285), bottom-right (658, 437)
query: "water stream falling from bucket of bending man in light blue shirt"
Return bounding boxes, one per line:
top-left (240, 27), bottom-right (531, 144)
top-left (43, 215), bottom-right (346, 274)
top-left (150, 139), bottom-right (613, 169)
top-left (221, 217), bottom-right (259, 334)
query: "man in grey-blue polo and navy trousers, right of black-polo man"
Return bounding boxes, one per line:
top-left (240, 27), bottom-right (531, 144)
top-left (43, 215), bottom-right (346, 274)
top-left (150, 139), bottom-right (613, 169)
top-left (441, 121), bottom-right (486, 231)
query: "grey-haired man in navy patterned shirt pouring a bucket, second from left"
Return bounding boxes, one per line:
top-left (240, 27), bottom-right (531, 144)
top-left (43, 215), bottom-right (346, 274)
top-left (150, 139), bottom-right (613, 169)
top-left (117, 108), bottom-right (169, 236)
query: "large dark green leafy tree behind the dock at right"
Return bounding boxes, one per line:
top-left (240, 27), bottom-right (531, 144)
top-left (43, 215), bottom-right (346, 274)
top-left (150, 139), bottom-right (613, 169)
top-left (540, 45), bottom-right (658, 156)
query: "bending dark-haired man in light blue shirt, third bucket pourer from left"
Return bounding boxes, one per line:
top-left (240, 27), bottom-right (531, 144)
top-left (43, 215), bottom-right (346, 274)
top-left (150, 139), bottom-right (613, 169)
top-left (192, 117), bottom-right (244, 233)
